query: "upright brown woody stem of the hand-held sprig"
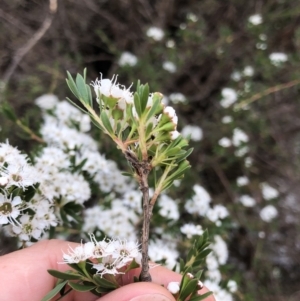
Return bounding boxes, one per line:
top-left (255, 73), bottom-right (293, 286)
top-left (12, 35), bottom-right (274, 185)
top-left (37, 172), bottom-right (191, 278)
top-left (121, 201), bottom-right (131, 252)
top-left (124, 150), bottom-right (153, 282)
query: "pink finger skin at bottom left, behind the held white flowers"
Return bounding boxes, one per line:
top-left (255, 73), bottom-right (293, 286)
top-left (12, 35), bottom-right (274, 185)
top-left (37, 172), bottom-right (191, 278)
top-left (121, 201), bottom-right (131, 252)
top-left (0, 240), bottom-right (97, 301)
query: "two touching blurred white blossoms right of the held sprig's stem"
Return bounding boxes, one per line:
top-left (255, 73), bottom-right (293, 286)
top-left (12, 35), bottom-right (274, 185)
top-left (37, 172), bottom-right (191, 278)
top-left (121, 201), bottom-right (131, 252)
top-left (184, 184), bottom-right (229, 226)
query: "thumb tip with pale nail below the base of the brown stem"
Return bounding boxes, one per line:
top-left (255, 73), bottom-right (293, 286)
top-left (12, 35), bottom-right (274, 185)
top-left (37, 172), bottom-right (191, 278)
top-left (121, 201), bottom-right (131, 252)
top-left (97, 282), bottom-right (175, 301)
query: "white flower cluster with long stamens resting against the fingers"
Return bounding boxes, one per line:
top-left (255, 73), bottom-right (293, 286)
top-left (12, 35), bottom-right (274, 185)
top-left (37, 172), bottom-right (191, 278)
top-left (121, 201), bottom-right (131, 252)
top-left (63, 235), bottom-right (141, 277)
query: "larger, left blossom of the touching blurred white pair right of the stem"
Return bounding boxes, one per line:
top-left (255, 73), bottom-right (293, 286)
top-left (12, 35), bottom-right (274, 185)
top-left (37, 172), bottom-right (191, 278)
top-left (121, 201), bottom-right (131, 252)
top-left (184, 184), bottom-right (211, 216)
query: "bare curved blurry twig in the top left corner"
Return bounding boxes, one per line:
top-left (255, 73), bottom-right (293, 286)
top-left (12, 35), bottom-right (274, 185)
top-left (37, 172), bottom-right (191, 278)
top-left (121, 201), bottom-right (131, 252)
top-left (3, 0), bottom-right (57, 88)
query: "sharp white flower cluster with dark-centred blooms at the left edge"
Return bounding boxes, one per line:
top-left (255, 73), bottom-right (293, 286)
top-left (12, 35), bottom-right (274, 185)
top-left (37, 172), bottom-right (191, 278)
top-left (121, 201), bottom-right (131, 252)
top-left (0, 143), bottom-right (57, 242)
